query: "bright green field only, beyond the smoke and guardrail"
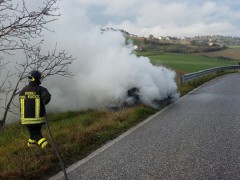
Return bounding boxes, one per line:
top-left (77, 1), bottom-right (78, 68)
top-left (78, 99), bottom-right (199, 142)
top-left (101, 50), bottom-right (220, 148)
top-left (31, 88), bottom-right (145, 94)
top-left (138, 51), bottom-right (237, 73)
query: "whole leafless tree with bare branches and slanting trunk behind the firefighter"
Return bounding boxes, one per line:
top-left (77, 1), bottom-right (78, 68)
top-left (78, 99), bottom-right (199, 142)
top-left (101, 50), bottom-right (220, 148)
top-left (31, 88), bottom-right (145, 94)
top-left (0, 0), bottom-right (74, 131)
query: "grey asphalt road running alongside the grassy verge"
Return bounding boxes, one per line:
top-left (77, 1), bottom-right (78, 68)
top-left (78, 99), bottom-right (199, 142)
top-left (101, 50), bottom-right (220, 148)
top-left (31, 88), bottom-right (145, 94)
top-left (52, 74), bottom-right (240, 180)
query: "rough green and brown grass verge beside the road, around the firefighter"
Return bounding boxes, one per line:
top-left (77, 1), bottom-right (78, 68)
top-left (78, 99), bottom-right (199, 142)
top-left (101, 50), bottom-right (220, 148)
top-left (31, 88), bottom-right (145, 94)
top-left (0, 106), bottom-right (156, 180)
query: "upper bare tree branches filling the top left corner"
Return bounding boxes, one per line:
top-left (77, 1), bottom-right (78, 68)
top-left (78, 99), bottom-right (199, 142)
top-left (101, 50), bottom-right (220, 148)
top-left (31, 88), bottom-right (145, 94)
top-left (0, 0), bottom-right (60, 53)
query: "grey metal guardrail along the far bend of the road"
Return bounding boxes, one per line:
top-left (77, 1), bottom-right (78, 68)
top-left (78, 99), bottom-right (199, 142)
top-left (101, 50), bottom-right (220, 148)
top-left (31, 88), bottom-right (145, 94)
top-left (180, 66), bottom-right (240, 86)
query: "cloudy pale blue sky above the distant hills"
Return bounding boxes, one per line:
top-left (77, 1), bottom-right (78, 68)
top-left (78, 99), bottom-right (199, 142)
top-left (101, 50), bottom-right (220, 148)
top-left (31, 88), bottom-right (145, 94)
top-left (60, 0), bottom-right (240, 37)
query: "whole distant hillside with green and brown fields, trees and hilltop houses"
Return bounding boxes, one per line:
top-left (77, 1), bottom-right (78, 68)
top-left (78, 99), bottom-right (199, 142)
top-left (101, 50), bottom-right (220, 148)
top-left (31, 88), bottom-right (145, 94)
top-left (132, 36), bottom-right (240, 74)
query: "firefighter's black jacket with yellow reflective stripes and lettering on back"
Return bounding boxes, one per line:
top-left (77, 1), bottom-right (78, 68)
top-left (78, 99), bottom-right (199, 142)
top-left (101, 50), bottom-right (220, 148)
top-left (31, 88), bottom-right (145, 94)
top-left (19, 83), bottom-right (51, 124)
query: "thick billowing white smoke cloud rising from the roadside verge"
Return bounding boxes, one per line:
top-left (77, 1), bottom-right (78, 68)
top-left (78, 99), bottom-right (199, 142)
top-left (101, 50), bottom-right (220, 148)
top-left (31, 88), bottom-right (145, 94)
top-left (39, 1), bottom-right (178, 111)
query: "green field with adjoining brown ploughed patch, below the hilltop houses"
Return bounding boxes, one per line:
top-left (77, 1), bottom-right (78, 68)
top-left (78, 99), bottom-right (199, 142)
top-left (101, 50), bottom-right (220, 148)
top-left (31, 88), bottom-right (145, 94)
top-left (138, 48), bottom-right (240, 73)
